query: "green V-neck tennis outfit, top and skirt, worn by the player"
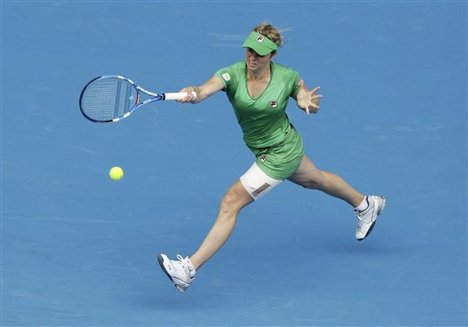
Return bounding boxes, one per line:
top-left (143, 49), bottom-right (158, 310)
top-left (215, 61), bottom-right (304, 180)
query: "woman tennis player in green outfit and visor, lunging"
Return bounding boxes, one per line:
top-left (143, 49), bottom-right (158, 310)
top-left (158, 23), bottom-right (385, 292)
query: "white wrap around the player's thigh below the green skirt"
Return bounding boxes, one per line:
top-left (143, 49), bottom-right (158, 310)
top-left (240, 162), bottom-right (283, 200)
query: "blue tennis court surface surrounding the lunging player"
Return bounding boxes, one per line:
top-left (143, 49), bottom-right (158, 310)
top-left (0, 0), bottom-right (468, 327)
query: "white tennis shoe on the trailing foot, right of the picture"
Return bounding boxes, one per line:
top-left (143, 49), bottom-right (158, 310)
top-left (356, 195), bottom-right (385, 241)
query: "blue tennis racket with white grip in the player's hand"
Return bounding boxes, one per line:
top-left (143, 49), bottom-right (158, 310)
top-left (80, 75), bottom-right (196, 123)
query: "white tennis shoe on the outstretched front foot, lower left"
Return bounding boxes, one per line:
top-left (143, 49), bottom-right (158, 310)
top-left (158, 254), bottom-right (196, 293)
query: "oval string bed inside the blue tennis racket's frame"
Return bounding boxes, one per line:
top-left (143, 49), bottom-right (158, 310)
top-left (80, 78), bottom-right (137, 121)
